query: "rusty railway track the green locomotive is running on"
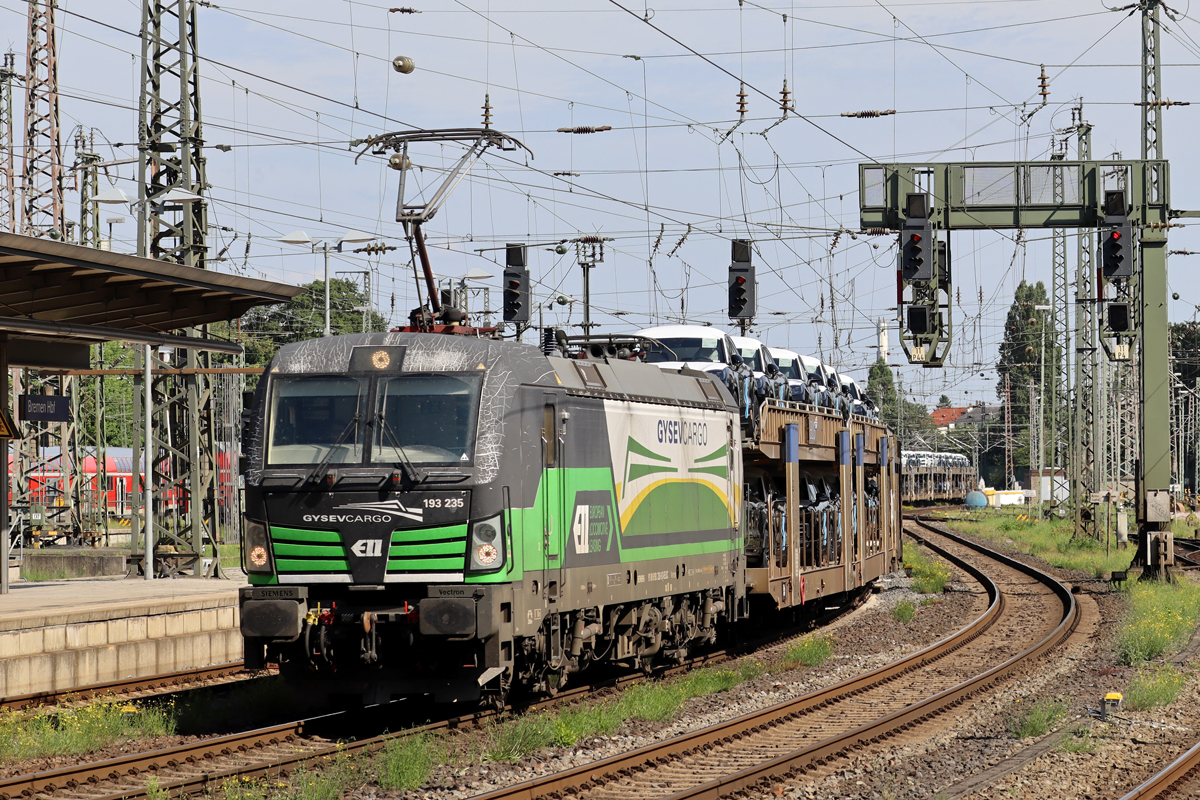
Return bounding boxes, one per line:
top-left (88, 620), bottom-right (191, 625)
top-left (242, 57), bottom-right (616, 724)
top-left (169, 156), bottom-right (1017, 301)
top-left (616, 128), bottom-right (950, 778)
top-left (0, 590), bottom-right (868, 800)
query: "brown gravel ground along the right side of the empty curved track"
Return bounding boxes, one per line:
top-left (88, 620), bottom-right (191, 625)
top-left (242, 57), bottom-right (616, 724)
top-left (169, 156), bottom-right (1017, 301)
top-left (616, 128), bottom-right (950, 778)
top-left (780, 527), bottom-right (1200, 800)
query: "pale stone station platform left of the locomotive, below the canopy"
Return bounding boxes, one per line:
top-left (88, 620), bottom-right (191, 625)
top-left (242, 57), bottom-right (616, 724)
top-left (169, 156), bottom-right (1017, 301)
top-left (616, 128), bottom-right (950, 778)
top-left (0, 573), bottom-right (246, 697)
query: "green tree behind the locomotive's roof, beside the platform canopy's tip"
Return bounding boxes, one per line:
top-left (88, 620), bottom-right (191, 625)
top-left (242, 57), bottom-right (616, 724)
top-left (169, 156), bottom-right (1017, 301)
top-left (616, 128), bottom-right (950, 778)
top-left (241, 278), bottom-right (388, 367)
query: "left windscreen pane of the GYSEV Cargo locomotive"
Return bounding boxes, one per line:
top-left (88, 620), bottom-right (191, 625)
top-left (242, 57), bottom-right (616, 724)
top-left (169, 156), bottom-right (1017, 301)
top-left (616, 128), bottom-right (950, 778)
top-left (266, 375), bottom-right (366, 464)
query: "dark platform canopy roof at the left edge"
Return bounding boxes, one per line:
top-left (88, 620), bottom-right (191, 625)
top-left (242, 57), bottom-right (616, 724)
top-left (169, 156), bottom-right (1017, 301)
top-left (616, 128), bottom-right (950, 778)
top-left (0, 231), bottom-right (301, 369)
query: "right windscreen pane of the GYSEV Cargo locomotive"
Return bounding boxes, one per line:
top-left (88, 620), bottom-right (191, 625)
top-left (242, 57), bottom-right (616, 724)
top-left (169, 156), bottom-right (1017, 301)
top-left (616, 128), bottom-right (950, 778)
top-left (371, 374), bottom-right (484, 464)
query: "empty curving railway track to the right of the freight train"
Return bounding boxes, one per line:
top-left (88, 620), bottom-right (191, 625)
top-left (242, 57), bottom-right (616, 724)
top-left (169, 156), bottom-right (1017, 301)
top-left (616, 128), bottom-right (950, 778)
top-left (460, 515), bottom-right (1078, 800)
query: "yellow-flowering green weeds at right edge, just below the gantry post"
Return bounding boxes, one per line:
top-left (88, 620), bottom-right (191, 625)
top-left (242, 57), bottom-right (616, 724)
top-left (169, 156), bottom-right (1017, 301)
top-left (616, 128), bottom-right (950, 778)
top-left (1116, 581), bottom-right (1200, 666)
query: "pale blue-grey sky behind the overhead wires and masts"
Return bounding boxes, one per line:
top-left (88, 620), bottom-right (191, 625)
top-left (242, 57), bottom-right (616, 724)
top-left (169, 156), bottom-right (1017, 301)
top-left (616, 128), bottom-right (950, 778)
top-left (0, 0), bottom-right (1200, 404)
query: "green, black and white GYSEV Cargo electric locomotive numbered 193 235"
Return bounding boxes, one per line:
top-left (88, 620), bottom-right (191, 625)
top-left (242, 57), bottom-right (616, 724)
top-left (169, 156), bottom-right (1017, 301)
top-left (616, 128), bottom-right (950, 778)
top-left (240, 332), bottom-right (744, 703)
